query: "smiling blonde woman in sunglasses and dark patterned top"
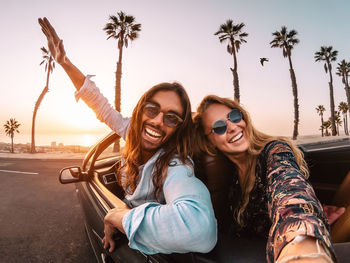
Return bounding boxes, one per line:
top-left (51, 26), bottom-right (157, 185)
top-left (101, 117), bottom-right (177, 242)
top-left (194, 95), bottom-right (335, 262)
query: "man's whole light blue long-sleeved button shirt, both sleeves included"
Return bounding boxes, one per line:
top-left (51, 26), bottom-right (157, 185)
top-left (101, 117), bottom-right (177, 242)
top-left (75, 75), bottom-right (217, 254)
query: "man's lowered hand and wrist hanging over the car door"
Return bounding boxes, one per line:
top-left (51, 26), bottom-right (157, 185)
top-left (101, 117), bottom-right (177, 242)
top-left (102, 208), bottom-right (130, 252)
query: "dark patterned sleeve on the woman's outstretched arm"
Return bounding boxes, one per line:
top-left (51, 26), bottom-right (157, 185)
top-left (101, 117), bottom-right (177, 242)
top-left (265, 142), bottom-right (334, 262)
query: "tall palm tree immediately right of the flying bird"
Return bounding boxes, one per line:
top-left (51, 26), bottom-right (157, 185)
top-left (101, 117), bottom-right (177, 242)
top-left (270, 26), bottom-right (299, 140)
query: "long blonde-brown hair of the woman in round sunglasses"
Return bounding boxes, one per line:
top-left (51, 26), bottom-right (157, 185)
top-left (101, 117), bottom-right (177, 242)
top-left (194, 95), bottom-right (309, 226)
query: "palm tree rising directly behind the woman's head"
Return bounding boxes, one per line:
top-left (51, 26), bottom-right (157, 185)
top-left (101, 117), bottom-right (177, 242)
top-left (214, 19), bottom-right (248, 102)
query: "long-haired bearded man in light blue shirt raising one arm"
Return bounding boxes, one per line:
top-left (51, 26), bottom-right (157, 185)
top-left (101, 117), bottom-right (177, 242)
top-left (39, 18), bottom-right (217, 254)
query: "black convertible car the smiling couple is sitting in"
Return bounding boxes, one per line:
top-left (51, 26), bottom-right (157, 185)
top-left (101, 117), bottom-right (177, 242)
top-left (59, 133), bottom-right (350, 263)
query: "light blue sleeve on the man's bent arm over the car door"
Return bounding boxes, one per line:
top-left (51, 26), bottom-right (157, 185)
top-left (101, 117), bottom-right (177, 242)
top-left (123, 165), bottom-right (217, 254)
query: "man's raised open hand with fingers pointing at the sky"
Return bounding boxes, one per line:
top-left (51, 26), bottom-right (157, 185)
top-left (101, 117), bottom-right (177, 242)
top-left (38, 17), bottom-right (67, 65)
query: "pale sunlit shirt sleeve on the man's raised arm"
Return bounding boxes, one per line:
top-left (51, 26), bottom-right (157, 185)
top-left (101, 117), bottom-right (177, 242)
top-left (75, 75), bottom-right (130, 139)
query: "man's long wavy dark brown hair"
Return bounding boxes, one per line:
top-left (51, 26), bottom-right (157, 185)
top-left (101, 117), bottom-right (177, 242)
top-left (118, 82), bottom-right (193, 200)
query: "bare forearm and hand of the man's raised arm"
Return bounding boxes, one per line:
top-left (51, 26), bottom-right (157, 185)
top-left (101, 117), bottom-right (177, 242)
top-left (38, 17), bottom-right (85, 90)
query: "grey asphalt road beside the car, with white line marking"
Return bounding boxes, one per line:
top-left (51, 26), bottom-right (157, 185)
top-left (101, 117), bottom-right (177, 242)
top-left (0, 158), bottom-right (96, 263)
